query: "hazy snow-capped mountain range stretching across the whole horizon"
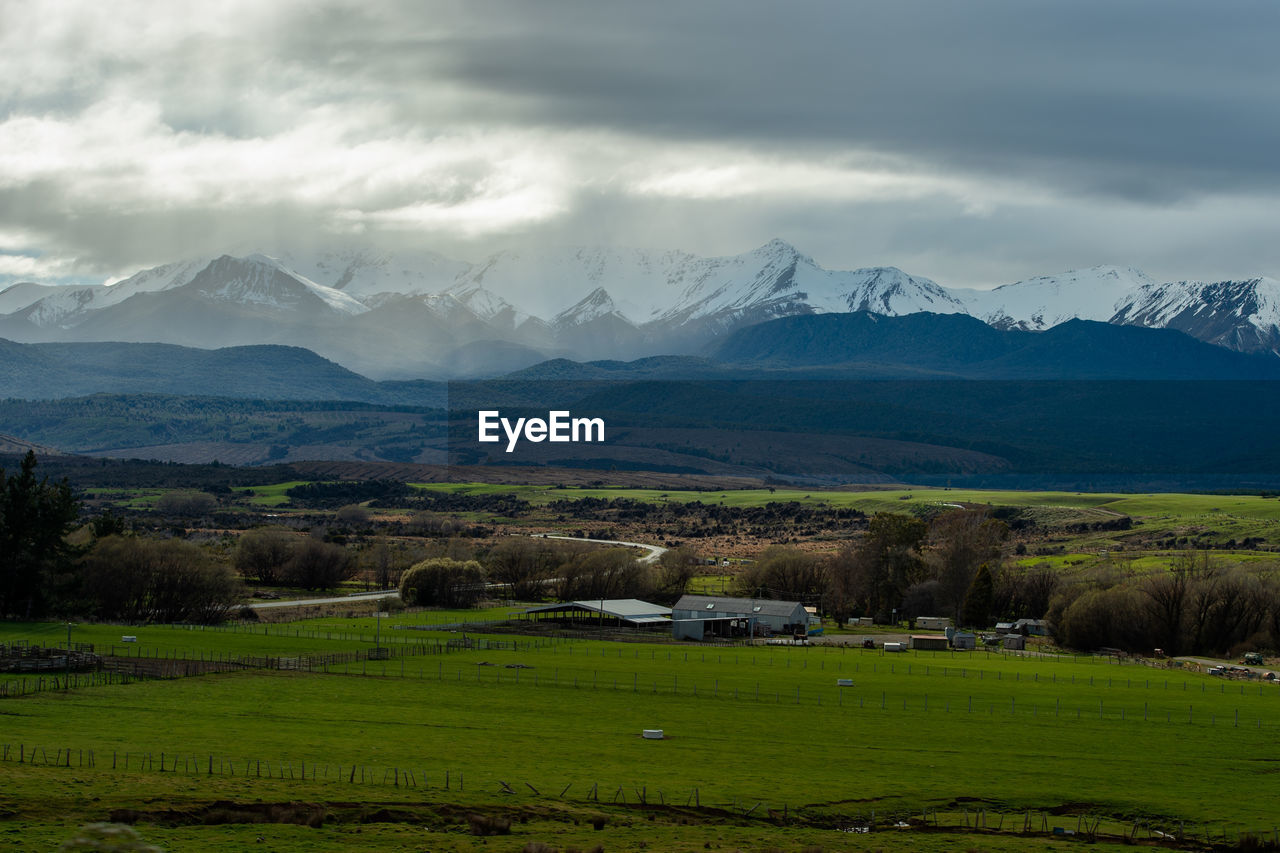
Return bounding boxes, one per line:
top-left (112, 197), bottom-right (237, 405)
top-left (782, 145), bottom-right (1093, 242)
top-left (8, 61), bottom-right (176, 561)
top-left (0, 240), bottom-right (1280, 379)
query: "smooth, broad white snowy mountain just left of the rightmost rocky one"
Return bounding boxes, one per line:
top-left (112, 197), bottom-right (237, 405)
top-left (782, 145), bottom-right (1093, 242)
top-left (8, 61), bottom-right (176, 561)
top-left (952, 266), bottom-right (1155, 332)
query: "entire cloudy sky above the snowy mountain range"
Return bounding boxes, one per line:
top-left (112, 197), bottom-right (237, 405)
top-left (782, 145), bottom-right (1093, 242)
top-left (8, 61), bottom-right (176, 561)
top-left (0, 0), bottom-right (1280, 287)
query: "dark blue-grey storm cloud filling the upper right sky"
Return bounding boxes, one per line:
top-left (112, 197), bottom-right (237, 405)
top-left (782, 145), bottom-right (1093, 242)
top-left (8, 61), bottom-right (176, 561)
top-left (293, 0), bottom-right (1280, 201)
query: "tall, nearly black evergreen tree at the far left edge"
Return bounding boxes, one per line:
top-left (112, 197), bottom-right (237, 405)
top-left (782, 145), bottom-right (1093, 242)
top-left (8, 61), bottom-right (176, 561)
top-left (0, 451), bottom-right (79, 619)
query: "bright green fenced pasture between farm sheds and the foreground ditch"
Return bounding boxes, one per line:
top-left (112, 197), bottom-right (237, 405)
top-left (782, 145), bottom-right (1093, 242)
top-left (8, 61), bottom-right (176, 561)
top-left (0, 613), bottom-right (1280, 849)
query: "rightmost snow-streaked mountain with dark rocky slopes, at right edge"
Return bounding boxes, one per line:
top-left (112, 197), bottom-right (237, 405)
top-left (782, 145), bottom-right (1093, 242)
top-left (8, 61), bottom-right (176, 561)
top-left (1108, 278), bottom-right (1280, 355)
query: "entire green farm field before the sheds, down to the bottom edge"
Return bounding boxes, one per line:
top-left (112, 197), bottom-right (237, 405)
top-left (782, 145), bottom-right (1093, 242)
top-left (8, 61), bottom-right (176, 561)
top-left (0, 613), bottom-right (1280, 850)
